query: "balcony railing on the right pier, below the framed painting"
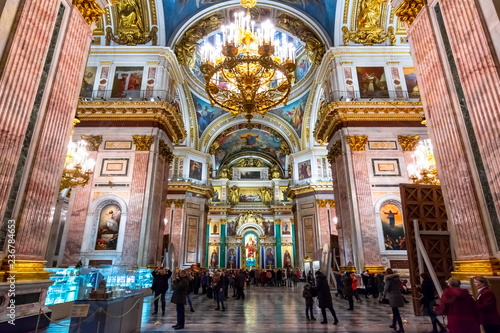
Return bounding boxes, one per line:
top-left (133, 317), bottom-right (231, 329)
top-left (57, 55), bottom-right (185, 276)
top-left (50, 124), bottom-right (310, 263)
top-left (325, 90), bottom-right (420, 103)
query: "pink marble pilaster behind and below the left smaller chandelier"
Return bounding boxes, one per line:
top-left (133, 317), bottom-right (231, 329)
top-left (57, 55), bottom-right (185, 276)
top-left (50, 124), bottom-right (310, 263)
top-left (61, 151), bottom-right (97, 265)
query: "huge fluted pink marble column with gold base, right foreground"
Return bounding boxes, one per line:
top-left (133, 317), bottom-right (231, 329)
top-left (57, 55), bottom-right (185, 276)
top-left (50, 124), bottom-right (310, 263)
top-left (408, 0), bottom-right (500, 276)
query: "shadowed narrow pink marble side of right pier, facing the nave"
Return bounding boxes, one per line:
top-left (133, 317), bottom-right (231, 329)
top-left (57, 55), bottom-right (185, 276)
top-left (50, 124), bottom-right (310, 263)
top-left (332, 155), bottom-right (354, 266)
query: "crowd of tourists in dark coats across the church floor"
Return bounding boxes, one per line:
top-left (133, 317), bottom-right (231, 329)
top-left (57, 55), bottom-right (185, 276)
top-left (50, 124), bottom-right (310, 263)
top-left (151, 268), bottom-right (500, 333)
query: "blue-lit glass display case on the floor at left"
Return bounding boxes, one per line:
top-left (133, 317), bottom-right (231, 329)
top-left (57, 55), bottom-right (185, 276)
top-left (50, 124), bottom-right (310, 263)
top-left (45, 266), bottom-right (153, 306)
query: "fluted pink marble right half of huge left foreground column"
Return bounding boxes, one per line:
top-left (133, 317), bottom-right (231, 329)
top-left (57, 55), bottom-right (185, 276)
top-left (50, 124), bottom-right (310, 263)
top-left (13, 5), bottom-right (90, 259)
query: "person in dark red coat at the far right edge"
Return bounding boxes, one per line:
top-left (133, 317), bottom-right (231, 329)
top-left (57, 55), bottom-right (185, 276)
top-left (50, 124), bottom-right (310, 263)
top-left (474, 276), bottom-right (500, 333)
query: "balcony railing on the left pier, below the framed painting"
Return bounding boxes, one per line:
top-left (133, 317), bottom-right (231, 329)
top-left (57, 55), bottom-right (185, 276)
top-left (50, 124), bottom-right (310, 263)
top-left (80, 90), bottom-right (174, 104)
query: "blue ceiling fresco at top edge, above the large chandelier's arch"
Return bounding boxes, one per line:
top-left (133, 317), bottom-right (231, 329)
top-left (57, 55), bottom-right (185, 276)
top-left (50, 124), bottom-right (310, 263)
top-left (163, 0), bottom-right (337, 44)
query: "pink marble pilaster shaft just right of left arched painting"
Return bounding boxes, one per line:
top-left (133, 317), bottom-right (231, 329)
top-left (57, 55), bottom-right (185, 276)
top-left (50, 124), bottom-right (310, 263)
top-left (120, 151), bottom-right (150, 265)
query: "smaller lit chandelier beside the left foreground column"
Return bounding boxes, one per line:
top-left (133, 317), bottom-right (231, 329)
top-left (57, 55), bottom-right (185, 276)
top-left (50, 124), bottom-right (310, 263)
top-left (59, 140), bottom-right (95, 191)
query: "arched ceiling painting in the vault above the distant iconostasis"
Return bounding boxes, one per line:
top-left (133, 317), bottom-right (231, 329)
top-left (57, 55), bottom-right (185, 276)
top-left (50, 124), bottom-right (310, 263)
top-left (213, 123), bottom-right (290, 168)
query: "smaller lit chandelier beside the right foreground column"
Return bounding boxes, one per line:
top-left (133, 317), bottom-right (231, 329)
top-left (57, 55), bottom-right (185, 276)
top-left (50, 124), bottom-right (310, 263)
top-left (408, 139), bottom-right (440, 185)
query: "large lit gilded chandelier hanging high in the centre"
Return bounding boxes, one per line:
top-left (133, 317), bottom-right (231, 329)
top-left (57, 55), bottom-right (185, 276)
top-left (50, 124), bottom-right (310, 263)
top-left (200, 0), bottom-right (296, 122)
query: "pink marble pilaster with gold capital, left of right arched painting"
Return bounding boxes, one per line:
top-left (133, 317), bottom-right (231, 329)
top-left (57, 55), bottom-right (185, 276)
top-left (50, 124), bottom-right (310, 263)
top-left (347, 135), bottom-right (381, 268)
